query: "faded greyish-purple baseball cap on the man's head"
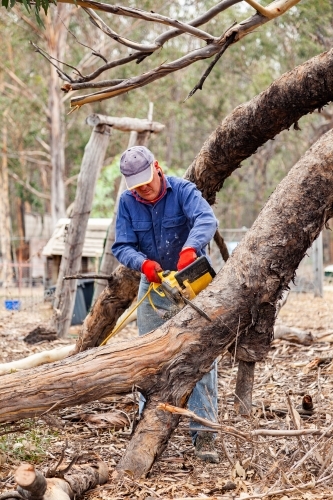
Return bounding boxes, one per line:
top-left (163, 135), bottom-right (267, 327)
top-left (120, 146), bottom-right (154, 189)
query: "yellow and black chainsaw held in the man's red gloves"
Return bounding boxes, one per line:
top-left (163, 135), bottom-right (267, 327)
top-left (153, 255), bottom-right (216, 321)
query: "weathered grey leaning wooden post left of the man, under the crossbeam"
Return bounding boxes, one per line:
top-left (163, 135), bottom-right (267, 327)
top-left (52, 125), bottom-right (110, 337)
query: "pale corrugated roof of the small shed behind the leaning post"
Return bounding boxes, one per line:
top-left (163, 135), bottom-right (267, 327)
top-left (42, 219), bottom-right (112, 257)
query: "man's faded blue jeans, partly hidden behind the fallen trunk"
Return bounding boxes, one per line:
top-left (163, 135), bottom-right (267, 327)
top-left (138, 275), bottom-right (217, 442)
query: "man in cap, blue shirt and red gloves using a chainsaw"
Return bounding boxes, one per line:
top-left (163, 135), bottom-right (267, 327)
top-left (112, 146), bottom-right (219, 463)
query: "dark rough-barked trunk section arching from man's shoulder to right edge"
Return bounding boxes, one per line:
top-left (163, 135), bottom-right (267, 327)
top-left (185, 49), bottom-right (333, 205)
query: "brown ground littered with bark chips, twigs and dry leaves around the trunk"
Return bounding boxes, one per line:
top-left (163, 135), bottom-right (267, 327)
top-left (0, 287), bottom-right (333, 500)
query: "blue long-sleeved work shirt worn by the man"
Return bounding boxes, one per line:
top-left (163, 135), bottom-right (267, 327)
top-left (112, 176), bottom-right (217, 271)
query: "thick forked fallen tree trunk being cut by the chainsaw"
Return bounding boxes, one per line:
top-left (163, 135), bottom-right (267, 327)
top-left (0, 127), bottom-right (333, 477)
